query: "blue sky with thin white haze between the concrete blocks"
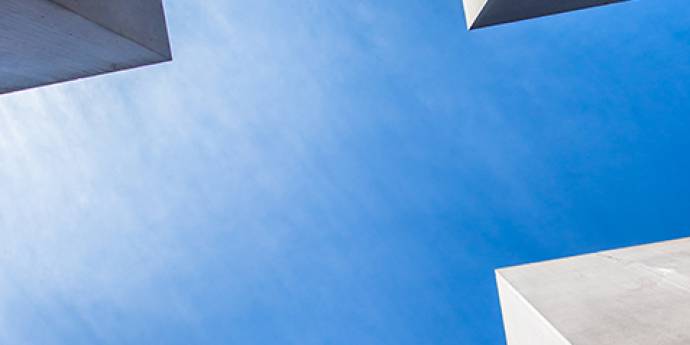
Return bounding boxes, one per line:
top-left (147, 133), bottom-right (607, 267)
top-left (0, 0), bottom-right (690, 345)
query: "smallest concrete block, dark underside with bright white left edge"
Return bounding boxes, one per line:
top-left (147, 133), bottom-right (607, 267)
top-left (463, 0), bottom-right (626, 30)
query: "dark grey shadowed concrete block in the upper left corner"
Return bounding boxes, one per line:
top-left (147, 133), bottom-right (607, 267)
top-left (0, 0), bottom-right (172, 94)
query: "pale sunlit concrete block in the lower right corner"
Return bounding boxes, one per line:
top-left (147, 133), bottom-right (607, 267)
top-left (496, 239), bottom-right (690, 345)
